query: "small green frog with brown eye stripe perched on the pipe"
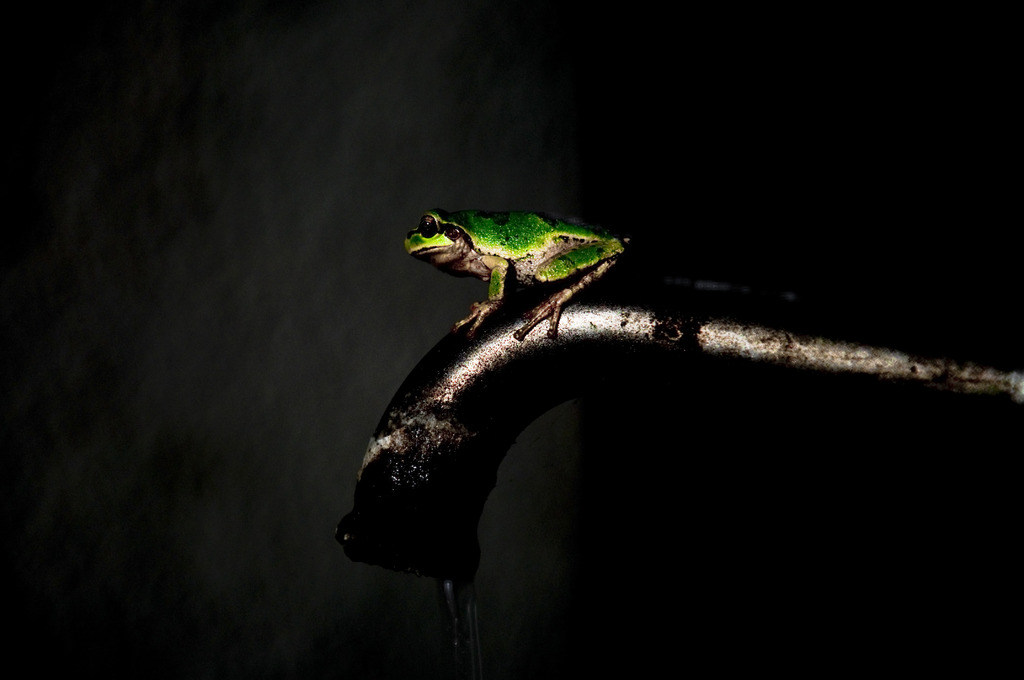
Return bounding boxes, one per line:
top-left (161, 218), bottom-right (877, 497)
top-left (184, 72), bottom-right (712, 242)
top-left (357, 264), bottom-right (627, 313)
top-left (404, 209), bottom-right (629, 341)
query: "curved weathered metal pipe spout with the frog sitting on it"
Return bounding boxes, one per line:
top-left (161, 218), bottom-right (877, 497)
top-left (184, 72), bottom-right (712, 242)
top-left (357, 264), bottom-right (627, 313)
top-left (336, 303), bottom-right (1024, 579)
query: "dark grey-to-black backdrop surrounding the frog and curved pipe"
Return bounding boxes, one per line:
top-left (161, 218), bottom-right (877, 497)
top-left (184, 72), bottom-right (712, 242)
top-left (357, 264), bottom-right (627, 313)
top-left (6, 0), bottom-right (1021, 678)
